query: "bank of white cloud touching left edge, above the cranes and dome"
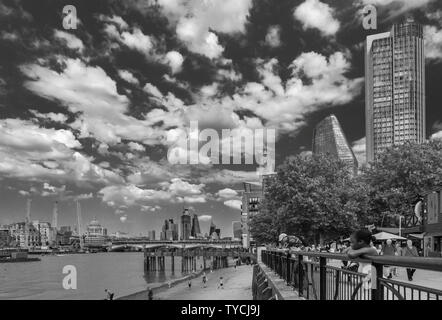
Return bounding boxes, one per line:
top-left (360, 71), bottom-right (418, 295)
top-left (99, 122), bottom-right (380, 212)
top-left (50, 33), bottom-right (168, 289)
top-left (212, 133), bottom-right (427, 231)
top-left (0, 119), bottom-right (122, 184)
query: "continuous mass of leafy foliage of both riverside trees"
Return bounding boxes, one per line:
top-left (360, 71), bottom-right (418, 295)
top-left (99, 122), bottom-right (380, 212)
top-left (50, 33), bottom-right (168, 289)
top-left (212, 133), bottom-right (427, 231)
top-left (250, 141), bottom-right (442, 243)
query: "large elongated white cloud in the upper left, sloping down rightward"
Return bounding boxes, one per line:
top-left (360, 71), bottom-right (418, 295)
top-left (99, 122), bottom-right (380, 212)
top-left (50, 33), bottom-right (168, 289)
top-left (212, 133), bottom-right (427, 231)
top-left (21, 58), bottom-right (167, 145)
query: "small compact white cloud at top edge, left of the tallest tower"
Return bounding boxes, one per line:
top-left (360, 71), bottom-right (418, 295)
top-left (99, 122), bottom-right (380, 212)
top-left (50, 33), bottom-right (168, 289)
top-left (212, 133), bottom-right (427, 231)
top-left (294, 0), bottom-right (340, 36)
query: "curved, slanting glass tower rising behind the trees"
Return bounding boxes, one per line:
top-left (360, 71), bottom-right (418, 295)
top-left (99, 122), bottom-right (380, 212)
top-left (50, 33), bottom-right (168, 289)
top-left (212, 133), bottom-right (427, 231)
top-left (312, 114), bottom-right (358, 175)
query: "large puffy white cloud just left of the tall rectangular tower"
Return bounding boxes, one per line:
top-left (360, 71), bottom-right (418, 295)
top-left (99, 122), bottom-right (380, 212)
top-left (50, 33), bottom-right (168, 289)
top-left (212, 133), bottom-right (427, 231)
top-left (231, 51), bottom-right (363, 133)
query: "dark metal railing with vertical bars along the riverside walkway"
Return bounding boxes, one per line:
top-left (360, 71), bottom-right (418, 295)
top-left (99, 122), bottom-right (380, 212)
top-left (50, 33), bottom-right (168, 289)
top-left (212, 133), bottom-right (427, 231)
top-left (261, 249), bottom-right (442, 300)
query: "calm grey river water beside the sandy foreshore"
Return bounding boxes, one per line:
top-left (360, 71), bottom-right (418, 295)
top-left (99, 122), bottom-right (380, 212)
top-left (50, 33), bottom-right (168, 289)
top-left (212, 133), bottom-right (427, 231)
top-left (0, 252), bottom-right (197, 300)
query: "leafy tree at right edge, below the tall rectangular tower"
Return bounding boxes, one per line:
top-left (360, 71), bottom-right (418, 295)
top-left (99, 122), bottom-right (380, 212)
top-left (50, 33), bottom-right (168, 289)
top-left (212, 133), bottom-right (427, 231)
top-left (362, 140), bottom-right (442, 226)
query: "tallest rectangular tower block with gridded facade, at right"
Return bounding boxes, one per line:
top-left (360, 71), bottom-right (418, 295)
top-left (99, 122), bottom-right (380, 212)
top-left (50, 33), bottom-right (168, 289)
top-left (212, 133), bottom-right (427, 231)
top-left (365, 18), bottom-right (425, 161)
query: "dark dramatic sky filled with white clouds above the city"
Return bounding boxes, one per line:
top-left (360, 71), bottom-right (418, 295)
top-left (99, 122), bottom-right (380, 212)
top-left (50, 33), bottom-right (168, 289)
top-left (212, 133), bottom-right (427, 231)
top-left (0, 0), bottom-right (442, 236)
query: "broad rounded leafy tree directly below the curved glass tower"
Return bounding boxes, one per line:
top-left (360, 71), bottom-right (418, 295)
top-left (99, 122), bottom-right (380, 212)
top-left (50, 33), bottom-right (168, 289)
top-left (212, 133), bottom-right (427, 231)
top-left (251, 155), bottom-right (361, 242)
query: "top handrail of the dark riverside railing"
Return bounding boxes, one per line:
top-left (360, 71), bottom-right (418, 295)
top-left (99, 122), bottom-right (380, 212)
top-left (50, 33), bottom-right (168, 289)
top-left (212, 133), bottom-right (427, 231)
top-left (266, 249), bottom-right (442, 272)
